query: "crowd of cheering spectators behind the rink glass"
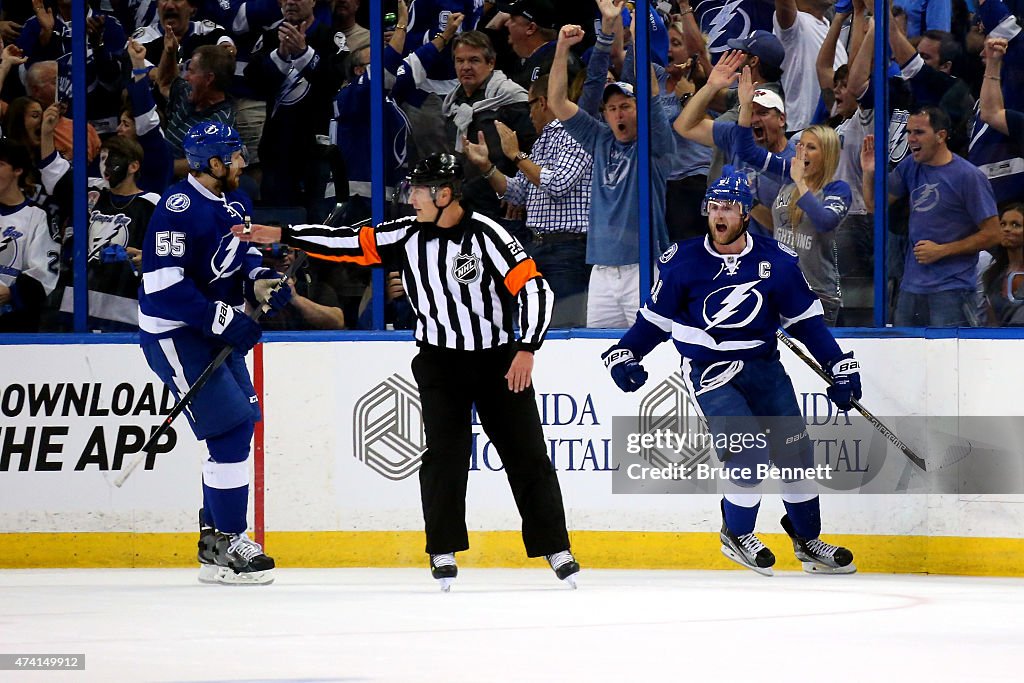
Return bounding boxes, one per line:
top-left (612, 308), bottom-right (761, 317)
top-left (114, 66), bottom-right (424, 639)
top-left (0, 0), bottom-right (1024, 332)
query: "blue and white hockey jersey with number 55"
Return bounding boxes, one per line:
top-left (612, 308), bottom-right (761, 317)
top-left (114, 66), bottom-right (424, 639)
top-left (138, 175), bottom-right (262, 341)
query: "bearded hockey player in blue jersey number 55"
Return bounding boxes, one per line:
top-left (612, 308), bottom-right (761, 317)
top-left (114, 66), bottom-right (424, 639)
top-left (138, 121), bottom-right (291, 584)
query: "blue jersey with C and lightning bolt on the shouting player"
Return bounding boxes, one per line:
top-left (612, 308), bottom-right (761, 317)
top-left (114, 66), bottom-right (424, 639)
top-left (639, 234), bottom-right (823, 362)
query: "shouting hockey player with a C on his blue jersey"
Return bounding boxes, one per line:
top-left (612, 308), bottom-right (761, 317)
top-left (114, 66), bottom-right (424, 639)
top-left (601, 166), bottom-right (861, 575)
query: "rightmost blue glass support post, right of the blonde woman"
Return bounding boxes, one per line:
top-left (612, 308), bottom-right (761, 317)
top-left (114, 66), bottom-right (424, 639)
top-left (871, 0), bottom-right (889, 328)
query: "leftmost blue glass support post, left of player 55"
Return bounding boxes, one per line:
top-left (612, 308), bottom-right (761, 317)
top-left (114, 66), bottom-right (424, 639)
top-left (71, 2), bottom-right (89, 332)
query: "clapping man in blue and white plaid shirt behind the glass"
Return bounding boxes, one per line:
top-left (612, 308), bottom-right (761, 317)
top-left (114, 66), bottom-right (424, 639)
top-left (463, 74), bottom-right (594, 328)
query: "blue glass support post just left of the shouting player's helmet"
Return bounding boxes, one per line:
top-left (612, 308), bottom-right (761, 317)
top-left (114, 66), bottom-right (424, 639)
top-left (633, 0), bottom-right (653, 302)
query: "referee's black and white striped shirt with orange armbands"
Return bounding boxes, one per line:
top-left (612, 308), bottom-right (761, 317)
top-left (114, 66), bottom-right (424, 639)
top-left (283, 212), bottom-right (554, 351)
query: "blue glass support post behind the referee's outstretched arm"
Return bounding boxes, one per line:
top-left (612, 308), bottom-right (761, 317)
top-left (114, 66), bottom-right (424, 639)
top-left (369, 0), bottom-right (387, 330)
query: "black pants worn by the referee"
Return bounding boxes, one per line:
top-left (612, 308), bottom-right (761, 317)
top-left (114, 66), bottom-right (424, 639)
top-left (413, 344), bottom-right (569, 557)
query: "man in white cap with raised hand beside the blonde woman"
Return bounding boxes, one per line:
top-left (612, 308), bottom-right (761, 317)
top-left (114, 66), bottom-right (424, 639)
top-left (673, 50), bottom-right (797, 234)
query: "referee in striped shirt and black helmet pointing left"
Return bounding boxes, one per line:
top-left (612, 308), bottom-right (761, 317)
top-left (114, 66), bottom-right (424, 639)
top-left (233, 154), bottom-right (580, 591)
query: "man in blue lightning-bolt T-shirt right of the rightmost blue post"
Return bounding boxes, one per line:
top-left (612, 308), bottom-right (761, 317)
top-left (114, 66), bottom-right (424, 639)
top-left (860, 106), bottom-right (999, 327)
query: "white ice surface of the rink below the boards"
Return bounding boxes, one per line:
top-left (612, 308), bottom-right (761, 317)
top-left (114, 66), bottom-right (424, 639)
top-left (0, 568), bottom-right (1024, 683)
